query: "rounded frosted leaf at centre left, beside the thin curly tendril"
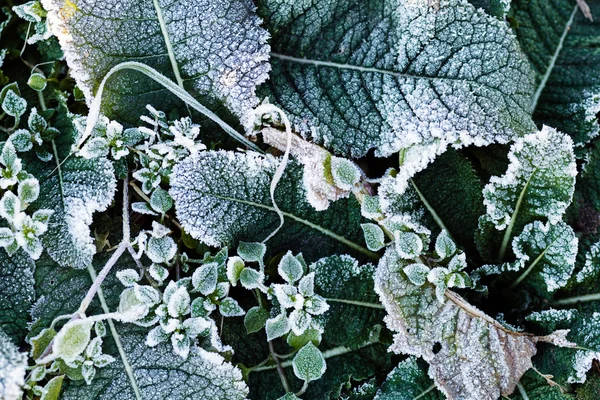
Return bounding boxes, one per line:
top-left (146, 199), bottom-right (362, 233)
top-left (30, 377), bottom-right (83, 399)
top-left (169, 151), bottom-right (278, 247)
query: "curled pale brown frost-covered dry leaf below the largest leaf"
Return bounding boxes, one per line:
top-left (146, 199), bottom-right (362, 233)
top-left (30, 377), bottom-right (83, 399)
top-left (262, 128), bottom-right (351, 211)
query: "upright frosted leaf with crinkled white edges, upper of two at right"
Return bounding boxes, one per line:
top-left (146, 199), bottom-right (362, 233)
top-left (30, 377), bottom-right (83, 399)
top-left (483, 126), bottom-right (577, 230)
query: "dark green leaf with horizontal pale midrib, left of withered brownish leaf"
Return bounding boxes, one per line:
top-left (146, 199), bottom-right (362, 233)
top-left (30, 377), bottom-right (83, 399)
top-left (309, 255), bottom-right (385, 349)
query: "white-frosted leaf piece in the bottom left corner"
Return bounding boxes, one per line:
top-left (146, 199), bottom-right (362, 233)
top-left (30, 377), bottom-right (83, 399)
top-left (0, 331), bottom-right (27, 400)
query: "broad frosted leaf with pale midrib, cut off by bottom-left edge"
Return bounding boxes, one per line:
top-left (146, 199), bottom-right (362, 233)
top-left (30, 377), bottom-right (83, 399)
top-left (61, 329), bottom-right (248, 400)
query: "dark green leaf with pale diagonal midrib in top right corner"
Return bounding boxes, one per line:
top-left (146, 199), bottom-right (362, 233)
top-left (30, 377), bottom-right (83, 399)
top-left (510, 0), bottom-right (600, 144)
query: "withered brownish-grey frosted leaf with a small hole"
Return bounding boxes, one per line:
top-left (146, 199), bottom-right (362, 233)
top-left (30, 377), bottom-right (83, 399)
top-left (375, 249), bottom-right (568, 400)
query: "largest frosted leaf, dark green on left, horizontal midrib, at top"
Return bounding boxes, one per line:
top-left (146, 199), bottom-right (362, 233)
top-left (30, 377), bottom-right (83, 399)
top-left (258, 0), bottom-right (534, 164)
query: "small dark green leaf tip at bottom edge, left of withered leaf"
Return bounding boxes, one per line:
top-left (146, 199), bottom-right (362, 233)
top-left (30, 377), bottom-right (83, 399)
top-left (374, 357), bottom-right (444, 400)
